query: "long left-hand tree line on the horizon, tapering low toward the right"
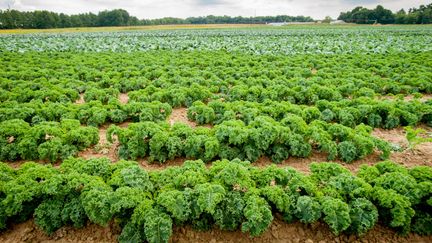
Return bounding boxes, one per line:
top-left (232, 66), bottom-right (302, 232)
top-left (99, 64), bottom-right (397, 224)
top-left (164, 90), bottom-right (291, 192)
top-left (0, 9), bottom-right (314, 29)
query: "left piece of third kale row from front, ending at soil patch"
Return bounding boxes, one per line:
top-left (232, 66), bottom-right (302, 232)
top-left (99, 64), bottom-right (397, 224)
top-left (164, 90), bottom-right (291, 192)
top-left (0, 99), bottom-right (172, 127)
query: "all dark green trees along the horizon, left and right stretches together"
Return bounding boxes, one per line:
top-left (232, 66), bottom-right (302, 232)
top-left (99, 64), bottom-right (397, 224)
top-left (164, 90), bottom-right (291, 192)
top-left (0, 4), bottom-right (432, 29)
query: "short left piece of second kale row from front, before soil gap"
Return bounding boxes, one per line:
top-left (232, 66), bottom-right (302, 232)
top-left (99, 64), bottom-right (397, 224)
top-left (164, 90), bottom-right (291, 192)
top-left (0, 119), bottom-right (99, 161)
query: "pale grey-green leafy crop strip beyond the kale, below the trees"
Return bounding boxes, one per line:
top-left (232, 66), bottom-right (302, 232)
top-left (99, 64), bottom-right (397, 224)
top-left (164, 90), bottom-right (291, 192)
top-left (0, 24), bottom-right (432, 55)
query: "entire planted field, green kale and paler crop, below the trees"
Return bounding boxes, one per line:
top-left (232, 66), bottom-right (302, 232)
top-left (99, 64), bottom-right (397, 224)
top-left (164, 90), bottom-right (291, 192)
top-left (0, 25), bottom-right (432, 242)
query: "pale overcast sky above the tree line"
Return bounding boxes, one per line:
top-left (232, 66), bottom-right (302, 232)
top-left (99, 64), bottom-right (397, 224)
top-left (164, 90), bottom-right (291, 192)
top-left (0, 0), bottom-right (431, 19)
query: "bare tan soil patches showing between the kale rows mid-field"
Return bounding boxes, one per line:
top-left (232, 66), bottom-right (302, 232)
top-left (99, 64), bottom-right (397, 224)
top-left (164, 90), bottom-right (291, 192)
top-left (78, 112), bottom-right (432, 173)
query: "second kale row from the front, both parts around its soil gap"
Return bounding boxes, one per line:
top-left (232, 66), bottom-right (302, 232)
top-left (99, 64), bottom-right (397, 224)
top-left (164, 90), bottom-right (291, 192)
top-left (0, 115), bottom-right (391, 163)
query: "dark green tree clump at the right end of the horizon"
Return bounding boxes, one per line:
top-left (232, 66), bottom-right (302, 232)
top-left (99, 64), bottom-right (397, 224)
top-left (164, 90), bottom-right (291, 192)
top-left (338, 3), bottom-right (432, 24)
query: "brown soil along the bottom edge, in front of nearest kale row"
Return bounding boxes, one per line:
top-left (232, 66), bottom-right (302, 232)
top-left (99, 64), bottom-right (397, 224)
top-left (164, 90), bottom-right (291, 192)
top-left (0, 216), bottom-right (432, 243)
